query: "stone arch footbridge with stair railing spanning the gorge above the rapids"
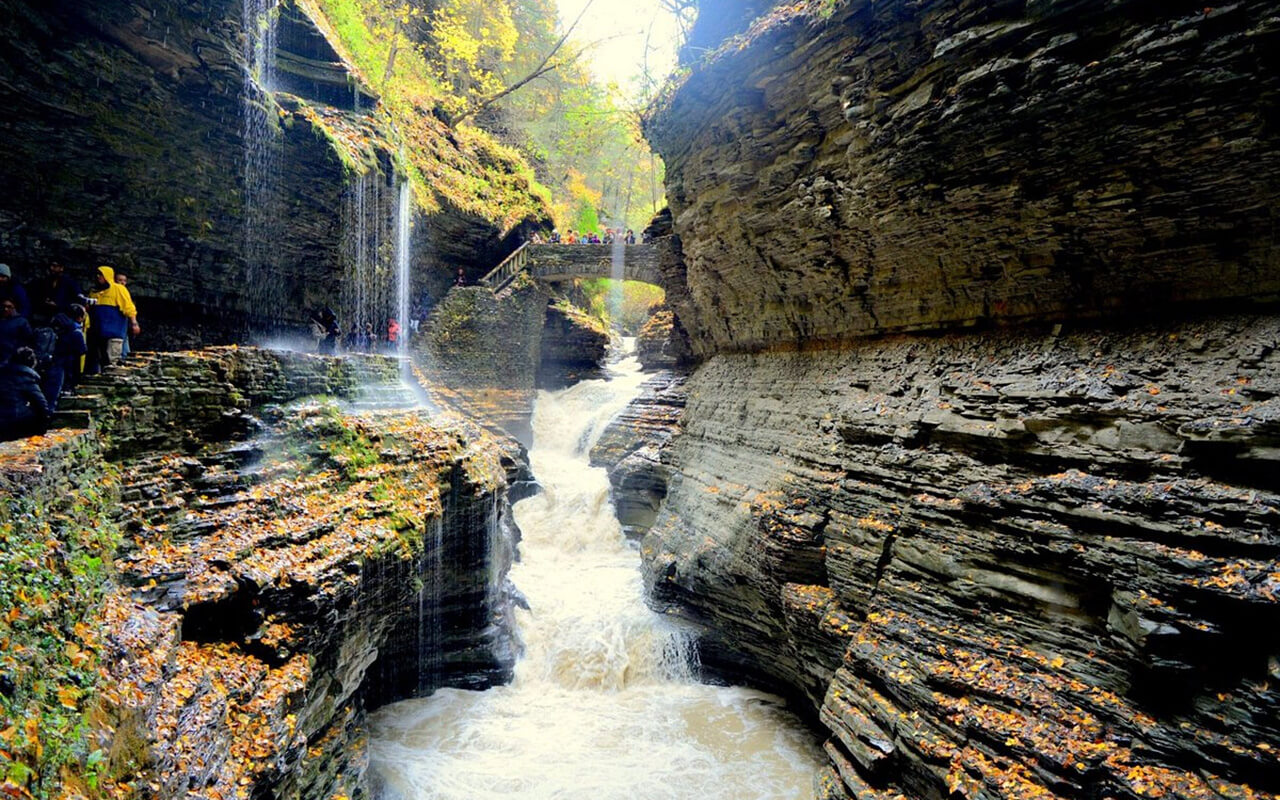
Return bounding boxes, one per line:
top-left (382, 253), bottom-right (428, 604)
top-left (480, 244), bottom-right (662, 292)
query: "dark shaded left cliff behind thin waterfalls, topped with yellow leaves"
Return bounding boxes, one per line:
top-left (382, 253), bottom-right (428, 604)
top-left (0, 0), bottom-right (539, 340)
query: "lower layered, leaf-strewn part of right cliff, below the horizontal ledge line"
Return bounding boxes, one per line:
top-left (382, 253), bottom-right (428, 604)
top-left (640, 316), bottom-right (1280, 799)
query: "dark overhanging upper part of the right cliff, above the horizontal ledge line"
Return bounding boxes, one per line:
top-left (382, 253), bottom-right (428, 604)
top-left (645, 0), bottom-right (1280, 355)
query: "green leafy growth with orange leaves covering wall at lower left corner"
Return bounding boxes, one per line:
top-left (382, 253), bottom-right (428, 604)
top-left (0, 444), bottom-right (120, 799)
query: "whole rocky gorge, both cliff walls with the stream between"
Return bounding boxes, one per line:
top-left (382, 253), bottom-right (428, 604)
top-left (0, 0), bottom-right (1280, 800)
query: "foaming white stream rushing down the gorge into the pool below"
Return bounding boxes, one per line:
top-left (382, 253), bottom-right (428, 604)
top-left (371, 343), bottom-right (819, 800)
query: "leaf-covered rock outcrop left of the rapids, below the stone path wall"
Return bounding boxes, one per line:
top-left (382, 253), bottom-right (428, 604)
top-left (108, 404), bottom-right (515, 799)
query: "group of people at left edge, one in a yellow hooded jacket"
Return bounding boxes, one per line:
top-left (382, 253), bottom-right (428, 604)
top-left (0, 261), bottom-right (142, 440)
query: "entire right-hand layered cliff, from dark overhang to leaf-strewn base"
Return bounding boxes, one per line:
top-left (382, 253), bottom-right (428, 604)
top-left (645, 0), bottom-right (1280, 800)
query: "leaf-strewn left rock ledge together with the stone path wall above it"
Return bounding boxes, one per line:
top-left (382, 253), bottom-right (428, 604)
top-left (0, 348), bottom-right (529, 800)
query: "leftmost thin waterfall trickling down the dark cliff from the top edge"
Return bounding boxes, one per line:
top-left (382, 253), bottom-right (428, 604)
top-left (242, 0), bottom-right (284, 320)
